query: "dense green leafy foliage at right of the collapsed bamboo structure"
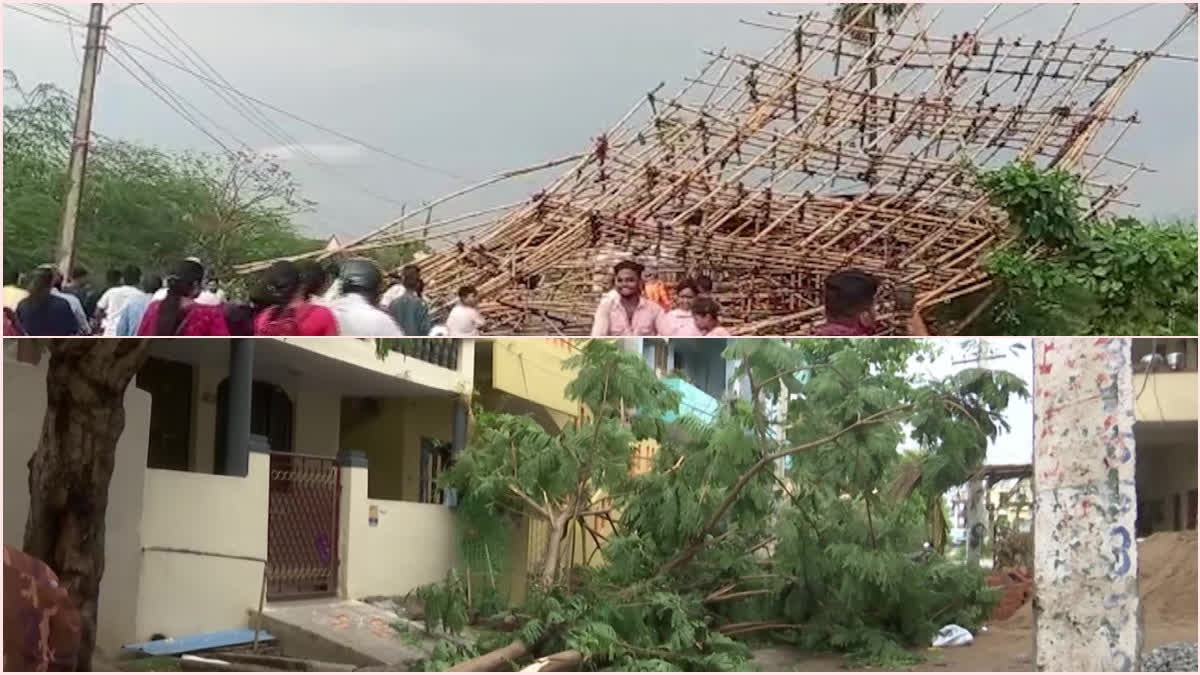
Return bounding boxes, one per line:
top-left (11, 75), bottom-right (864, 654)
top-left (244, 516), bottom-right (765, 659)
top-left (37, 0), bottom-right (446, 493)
top-left (971, 162), bottom-right (1198, 335)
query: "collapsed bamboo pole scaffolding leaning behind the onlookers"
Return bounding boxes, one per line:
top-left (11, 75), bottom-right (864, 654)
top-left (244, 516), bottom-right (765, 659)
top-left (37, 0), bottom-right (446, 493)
top-left (236, 5), bottom-right (1194, 335)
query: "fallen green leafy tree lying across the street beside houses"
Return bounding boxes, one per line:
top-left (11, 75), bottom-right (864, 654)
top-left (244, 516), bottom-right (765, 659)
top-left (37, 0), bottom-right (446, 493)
top-left (425, 340), bottom-right (1026, 670)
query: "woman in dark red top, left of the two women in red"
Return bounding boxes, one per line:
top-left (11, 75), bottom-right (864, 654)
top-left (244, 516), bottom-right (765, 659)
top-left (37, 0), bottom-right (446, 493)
top-left (138, 261), bottom-right (229, 338)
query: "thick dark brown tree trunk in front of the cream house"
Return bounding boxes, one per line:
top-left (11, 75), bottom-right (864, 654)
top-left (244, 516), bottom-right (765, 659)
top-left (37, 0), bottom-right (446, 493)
top-left (24, 339), bottom-right (150, 670)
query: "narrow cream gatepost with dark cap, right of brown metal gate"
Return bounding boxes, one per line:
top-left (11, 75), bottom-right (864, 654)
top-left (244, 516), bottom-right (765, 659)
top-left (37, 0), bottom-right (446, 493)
top-left (337, 450), bottom-right (367, 599)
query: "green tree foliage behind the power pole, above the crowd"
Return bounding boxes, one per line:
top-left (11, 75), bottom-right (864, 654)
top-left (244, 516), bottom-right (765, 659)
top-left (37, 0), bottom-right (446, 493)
top-left (4, 73), bottom-right (322, 274)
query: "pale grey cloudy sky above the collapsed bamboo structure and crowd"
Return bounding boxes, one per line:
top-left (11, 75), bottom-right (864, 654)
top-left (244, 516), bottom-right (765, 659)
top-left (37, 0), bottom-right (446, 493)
top-left (4, 4), bottom-right (1196, 239)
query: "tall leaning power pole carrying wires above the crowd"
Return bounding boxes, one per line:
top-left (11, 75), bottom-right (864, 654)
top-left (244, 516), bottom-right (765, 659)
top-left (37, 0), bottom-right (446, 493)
top-left (58, 2), bottom-right (104, 279)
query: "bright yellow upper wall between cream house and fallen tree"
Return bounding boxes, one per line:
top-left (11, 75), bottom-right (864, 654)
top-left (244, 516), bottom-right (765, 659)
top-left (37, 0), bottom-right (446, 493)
top-left (492, 338), bottom-right (578, 416)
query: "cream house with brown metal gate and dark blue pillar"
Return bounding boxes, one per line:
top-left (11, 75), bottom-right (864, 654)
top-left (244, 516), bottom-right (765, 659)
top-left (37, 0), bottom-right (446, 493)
top-left (4, 338), bottom-right (475, 650)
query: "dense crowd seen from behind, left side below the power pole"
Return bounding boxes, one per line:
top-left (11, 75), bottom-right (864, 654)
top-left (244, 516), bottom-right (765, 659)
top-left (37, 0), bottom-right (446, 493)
top-left (4, 258), bottom-right (486, 338)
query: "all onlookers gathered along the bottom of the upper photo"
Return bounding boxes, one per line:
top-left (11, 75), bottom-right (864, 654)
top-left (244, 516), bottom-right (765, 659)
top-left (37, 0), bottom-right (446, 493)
top-left (4, 252), bottom-right (929, 338)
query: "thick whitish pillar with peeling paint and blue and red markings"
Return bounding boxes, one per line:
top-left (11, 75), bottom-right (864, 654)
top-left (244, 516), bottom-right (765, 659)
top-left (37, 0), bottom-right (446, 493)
top-left (1033, 338), bottom-right (1142, 671)
